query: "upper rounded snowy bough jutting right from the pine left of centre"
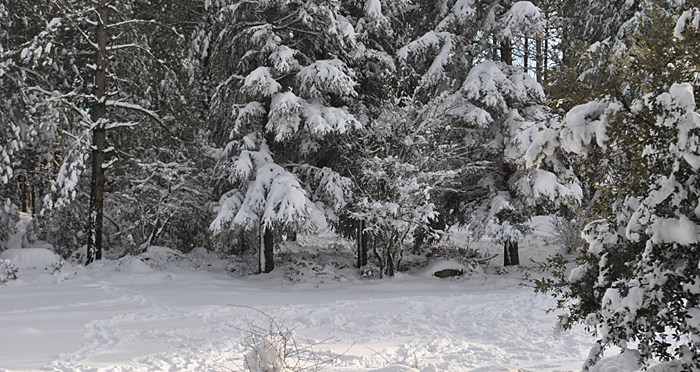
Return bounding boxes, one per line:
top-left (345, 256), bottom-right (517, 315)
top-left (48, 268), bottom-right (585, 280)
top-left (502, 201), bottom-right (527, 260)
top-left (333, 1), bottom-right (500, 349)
top-left (297, 59), bottom-right (357, 98)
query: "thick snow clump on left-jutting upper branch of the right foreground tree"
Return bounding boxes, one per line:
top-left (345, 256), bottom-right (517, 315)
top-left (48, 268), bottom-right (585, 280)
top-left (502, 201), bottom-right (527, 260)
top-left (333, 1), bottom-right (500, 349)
top-left (559, 101), bottom-right (619, 155)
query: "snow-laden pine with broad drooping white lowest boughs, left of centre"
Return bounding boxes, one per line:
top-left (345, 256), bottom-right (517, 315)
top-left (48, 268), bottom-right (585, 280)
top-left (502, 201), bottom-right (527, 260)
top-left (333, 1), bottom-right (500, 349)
top-left (200, 0), bottom-right (360, 272)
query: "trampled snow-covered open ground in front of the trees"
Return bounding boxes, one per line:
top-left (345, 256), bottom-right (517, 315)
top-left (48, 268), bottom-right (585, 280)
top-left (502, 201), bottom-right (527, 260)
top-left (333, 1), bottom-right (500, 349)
top-left (0, 217), bottom-right (636, 372)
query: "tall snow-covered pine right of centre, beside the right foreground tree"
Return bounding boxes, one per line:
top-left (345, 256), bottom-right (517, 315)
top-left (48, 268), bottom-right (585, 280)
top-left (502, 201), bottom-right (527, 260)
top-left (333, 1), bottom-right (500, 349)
top-left (398, 1), bottom-right (544, 265)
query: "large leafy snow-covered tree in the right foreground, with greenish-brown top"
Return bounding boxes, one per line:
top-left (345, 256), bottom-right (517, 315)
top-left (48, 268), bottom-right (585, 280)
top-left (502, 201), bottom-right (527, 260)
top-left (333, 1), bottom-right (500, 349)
top-left (537, 1), bottom-right (700, 371)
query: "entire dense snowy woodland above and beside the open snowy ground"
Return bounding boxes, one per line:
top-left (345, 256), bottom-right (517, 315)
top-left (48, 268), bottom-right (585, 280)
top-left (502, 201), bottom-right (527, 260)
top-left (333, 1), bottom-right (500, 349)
top-left (0, 0), bottom-right (700, 368)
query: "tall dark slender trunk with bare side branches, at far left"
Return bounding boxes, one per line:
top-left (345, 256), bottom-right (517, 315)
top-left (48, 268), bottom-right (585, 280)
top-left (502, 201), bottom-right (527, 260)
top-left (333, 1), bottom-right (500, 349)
top-left (85, 0), bottom-right (108, 265)
